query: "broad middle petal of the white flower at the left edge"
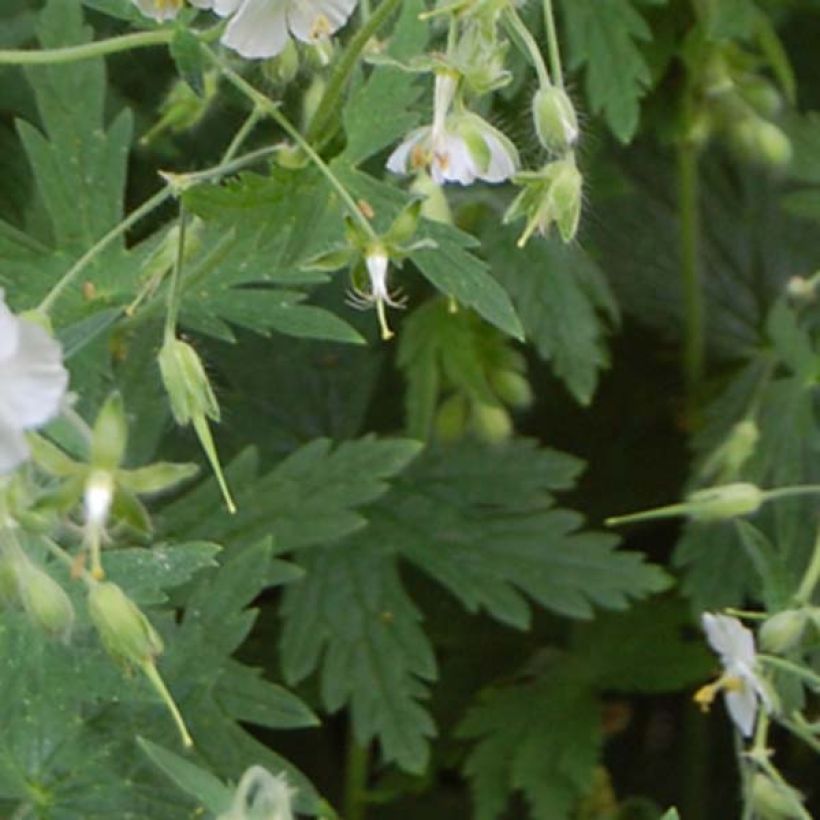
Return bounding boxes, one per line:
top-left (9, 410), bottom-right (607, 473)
top-left (0, 319), bottom-right (68, 430)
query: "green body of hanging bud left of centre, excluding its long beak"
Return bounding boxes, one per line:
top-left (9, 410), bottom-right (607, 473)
top-left (159, 338), bottom-right (220, 424)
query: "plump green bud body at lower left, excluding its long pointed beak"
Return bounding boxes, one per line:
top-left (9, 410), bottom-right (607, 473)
top-left (88, 582), bottom-right (163, 666)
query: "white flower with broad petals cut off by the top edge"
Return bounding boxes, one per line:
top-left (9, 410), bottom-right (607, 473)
top-left (191, 0), bottom-right (356, 58)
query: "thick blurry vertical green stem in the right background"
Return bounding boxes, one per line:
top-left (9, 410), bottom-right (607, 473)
top-left (678, 142), bottom-right (705, 416)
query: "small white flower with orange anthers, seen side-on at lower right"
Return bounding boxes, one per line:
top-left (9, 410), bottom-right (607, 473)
top-left (695, 612), bottom-right (772, 737)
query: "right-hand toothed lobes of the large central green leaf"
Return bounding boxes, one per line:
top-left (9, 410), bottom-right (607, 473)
top-left (382, 440), bottom-right (669, 628)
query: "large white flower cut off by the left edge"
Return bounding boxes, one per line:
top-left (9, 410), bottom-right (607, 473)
top-left (0, 290), bottom-right (68, 475)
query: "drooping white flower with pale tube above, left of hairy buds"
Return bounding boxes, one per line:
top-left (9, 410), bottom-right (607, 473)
top-left (387, 72), bottom-right (518, 185)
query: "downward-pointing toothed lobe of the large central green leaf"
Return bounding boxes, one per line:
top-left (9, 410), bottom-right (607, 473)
top-left (281, 538), bottom-right (436, 772)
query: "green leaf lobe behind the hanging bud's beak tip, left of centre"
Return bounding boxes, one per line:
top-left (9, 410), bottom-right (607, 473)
top-left (163, 436), bottom-right (420, 552)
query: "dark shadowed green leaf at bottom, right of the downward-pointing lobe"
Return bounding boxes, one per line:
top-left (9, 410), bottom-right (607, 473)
top-left (458, 664), bottom-right (602, 820)
